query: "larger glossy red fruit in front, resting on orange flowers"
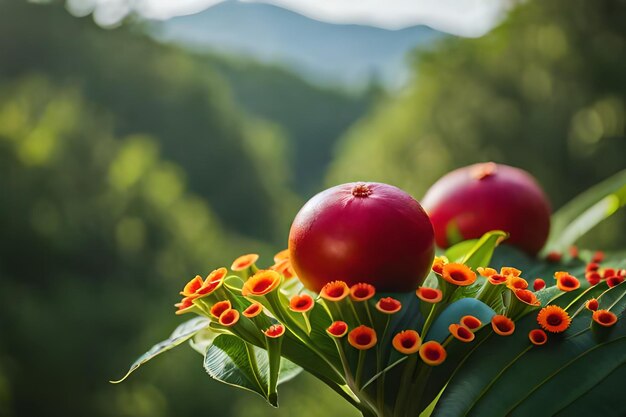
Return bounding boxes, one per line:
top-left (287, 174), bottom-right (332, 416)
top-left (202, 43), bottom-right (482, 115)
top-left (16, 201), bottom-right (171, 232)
top-left (289, 182), bottom-right (435, 292)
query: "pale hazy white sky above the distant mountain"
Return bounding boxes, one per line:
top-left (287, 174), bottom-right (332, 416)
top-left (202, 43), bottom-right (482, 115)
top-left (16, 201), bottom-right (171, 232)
top-left (73, 0), bottom-right (510, 36)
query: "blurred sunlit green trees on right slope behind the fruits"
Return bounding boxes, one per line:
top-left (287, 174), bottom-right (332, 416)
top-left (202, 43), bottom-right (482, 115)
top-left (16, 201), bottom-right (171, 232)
top-left (328, 0), bottom-right (626, 246)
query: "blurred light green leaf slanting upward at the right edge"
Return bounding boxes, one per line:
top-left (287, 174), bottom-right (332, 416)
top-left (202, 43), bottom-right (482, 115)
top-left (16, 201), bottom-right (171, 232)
top-left (545, 170), bottom-right (626, 252)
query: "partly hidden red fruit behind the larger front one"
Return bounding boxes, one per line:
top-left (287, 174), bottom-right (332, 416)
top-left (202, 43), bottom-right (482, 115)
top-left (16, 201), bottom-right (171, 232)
top-left (422, 162), bottom-right (551, 255)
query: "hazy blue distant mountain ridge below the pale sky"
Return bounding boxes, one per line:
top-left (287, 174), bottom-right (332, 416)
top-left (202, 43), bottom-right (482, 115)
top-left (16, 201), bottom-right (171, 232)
top-left (154, 0), bottom-right (443, 86)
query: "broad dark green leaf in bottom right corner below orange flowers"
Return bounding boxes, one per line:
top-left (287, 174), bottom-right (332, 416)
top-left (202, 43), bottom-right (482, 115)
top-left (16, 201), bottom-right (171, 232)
top-left (424, 285), bottom-right (626, 417)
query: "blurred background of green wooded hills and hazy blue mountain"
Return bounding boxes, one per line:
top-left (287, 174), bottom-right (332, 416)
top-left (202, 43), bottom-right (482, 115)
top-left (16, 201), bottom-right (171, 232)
top-left (0, 0), bottom-right (626, 417)
